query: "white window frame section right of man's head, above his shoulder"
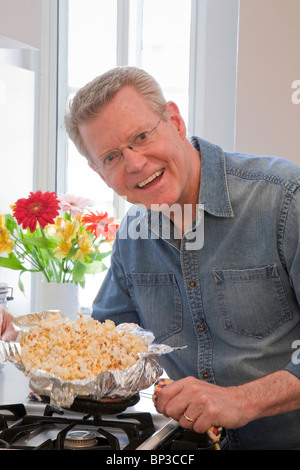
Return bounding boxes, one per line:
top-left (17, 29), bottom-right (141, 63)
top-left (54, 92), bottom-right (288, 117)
top-left (188, 0), bottom-right (240, 151)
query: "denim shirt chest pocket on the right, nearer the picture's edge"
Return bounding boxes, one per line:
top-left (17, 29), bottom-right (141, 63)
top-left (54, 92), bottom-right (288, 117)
top-left (214, 265), bottom-right (292, 338)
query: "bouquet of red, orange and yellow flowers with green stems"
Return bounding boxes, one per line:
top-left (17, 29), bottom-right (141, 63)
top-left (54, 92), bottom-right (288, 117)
top-left (0, 191), bottom-right (118, 292)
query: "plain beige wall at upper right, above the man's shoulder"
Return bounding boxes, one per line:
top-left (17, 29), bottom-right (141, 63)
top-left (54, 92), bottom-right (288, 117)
top-left (236, 0), bottom-right (300, 165)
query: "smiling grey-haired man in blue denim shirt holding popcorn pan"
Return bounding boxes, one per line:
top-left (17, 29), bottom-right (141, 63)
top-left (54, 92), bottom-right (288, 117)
top-left (1, 67), bottom-right (300, 449)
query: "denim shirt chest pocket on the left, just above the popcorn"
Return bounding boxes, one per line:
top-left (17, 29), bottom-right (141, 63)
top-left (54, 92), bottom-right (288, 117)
top-left (126, 273), bottom-right (182, 342)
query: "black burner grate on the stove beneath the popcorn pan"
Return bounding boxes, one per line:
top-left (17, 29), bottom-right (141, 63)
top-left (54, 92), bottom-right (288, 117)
top-left (0, 405), bottom-right (155, 450)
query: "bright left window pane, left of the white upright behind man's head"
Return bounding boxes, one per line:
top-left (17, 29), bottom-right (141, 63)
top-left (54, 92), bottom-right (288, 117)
top-left (58, 0), bottom-right (117, 213)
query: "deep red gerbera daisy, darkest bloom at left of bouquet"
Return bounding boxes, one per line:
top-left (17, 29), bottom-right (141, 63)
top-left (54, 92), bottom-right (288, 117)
top-left (13, 191), bottom-right (60, 233)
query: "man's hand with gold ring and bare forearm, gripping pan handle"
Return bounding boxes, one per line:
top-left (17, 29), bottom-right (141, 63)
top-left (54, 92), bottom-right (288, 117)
top-left (157, 370), bottom-right (300, 433)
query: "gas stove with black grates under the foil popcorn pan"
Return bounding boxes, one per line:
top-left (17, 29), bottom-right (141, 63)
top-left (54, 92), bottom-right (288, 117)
top-left (0, 364), bottom-right (226, 451)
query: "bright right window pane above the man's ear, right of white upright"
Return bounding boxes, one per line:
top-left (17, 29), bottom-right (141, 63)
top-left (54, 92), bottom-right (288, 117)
top-left (128, 0), bottom-right (191, 122)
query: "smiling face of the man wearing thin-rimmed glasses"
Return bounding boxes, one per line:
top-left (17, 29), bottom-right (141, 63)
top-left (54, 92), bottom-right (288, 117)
top-left (79, 87), bottom-right (200, 212)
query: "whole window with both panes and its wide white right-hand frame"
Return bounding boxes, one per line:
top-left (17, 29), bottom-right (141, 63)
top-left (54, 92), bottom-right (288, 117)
top-left (56, 0), bottom-right (239, 310)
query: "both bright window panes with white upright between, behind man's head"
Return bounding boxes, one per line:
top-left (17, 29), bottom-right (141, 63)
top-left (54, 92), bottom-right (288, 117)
top-left (58, 0), bottom-right (191, 213)
